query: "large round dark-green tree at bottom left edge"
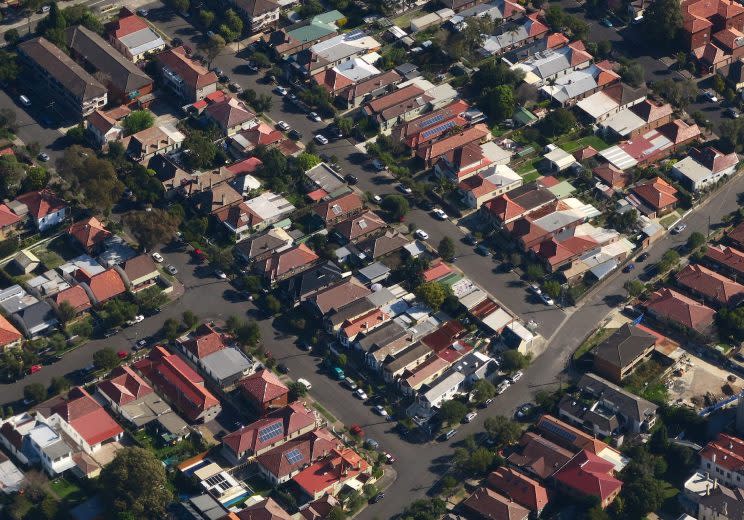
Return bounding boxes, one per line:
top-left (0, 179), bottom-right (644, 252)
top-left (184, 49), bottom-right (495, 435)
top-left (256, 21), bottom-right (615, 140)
top-left (100, 448), bottom-right (173, 520)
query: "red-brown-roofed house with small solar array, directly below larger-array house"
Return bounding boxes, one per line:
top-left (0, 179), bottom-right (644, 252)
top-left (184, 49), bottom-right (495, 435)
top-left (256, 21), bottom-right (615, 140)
top-left (256, 428), bottom-right (342, 486)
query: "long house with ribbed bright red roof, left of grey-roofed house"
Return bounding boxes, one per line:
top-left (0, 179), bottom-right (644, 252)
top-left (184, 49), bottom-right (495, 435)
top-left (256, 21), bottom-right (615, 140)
top-left (134, 346), bottom-right (222, 422)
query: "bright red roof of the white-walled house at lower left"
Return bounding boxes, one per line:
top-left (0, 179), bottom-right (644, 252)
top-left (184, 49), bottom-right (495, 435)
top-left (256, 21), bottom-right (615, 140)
top-left (52, 386), bottom-right (124, 446)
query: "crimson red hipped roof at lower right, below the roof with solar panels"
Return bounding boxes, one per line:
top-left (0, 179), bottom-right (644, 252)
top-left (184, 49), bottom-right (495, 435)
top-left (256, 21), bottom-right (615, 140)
top-left (555, 450), bottom-right (623, 502)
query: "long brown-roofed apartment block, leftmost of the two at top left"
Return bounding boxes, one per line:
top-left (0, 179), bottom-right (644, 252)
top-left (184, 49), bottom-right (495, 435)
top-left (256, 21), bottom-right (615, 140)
top-left (18, 37), bottom-right (108, 117)
